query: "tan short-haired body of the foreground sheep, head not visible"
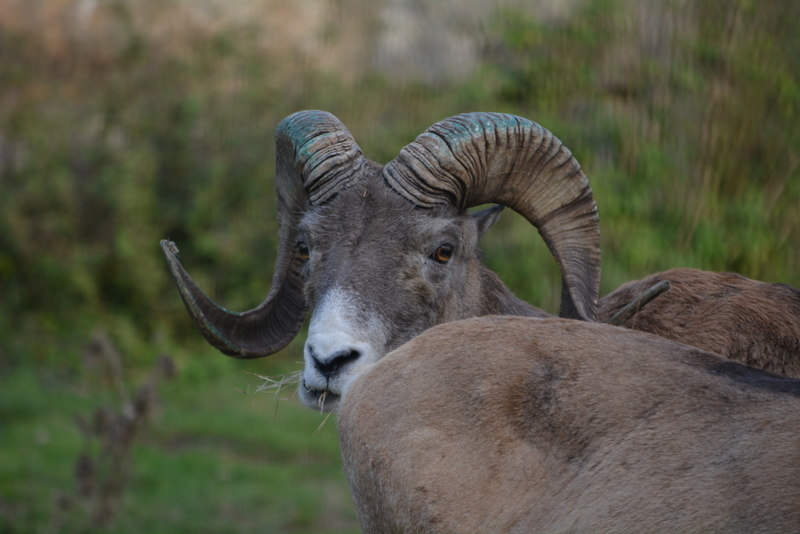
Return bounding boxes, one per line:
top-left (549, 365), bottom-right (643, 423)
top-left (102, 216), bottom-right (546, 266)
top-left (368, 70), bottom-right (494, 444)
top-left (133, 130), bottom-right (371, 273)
top-left (339, 317), bottom-right (800, 534)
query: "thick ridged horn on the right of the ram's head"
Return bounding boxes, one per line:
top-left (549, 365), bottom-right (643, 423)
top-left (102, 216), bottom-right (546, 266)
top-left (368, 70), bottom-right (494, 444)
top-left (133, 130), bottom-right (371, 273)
top-left (383, 113), bottom-right (600, 320)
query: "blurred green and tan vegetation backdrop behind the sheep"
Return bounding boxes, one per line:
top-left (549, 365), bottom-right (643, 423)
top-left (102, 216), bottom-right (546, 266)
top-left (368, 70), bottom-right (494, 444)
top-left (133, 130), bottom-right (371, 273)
top-left (0, 0), bottom-right (800, 533)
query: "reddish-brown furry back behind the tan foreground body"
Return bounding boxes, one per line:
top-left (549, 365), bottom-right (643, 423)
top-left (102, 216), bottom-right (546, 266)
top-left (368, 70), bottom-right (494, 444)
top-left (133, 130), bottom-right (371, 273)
top-left (597, 269), bottom-right (800, 378)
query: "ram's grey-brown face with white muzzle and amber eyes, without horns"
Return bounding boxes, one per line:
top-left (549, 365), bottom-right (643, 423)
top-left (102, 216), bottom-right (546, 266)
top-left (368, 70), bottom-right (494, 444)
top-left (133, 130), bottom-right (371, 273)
top-left (296, 176), bottom-right (502, 410)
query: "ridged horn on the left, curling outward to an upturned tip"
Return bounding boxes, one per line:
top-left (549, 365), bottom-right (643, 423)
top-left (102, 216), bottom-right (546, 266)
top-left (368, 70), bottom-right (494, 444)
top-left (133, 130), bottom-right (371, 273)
top-left (161, 111), bottom-right (367, 358)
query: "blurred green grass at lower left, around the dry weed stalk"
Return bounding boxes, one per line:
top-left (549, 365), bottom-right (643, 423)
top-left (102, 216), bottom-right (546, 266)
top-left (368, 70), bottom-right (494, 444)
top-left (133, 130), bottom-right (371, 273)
top-left (0, 362), bottom-right (359, 533)
